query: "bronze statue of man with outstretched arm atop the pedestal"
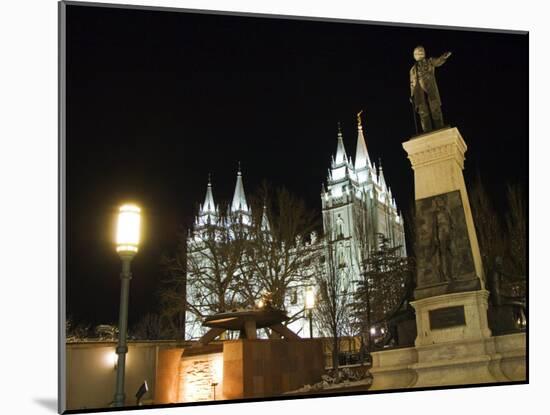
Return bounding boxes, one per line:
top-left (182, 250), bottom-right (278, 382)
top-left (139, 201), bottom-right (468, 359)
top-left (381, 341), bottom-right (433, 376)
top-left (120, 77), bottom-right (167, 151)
top-left (410, 46), bottom-right (451, 133)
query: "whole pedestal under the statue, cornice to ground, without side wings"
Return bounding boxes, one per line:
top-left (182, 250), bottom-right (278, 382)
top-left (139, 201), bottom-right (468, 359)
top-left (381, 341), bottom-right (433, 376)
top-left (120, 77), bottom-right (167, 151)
top-left (403, 128), bottom-right (506, 387)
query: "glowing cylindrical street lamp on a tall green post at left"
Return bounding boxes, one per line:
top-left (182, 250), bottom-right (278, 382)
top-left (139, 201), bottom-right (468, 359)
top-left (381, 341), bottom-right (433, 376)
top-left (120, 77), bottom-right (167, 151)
top-left (113, 205), bottom-right (141, 406)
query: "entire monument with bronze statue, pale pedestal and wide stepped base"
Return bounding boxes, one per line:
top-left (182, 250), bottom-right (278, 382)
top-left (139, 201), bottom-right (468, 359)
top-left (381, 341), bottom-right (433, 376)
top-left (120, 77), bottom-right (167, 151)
top-left (352, 50), bottom-right (526, 390)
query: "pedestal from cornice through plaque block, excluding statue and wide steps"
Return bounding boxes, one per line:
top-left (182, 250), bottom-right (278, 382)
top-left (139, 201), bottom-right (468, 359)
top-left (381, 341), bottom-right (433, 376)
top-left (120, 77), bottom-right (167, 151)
top-left (403, 128), bottom-right (491, 346)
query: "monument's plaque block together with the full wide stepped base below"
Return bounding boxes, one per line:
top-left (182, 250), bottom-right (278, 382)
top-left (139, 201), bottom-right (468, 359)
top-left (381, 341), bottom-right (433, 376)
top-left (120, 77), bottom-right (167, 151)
top-left (370, 290), bottom-right (526, 390)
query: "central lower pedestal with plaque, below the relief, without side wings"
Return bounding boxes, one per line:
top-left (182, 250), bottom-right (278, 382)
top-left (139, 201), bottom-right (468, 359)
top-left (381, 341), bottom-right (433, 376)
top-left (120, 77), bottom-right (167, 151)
top-left (411, 290), bottom-right (508, 387)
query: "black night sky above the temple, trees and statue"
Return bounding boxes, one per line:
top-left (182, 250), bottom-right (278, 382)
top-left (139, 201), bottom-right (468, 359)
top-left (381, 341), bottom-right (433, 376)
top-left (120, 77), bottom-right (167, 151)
top-left (66, 5), bottom-right (528, 325)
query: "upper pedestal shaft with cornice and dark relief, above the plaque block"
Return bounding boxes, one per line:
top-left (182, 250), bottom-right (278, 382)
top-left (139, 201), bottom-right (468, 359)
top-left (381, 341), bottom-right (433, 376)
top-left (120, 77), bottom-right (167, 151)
top-left (403, 128), bottom-right (484, 300)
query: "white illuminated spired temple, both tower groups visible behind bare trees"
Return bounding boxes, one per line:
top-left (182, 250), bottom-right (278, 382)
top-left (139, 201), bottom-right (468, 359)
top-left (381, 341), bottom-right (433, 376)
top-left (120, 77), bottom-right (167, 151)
top-left (186, 118), bottom-right (406, 339)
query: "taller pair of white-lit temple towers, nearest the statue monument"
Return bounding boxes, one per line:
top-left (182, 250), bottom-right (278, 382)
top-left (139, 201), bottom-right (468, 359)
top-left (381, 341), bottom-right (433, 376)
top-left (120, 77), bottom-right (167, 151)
top-left (321, 119), bottom-right (406, 296)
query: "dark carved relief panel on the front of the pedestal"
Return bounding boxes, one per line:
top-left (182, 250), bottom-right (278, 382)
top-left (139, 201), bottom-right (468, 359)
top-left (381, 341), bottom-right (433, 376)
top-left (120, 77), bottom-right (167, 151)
top-left (416, 190), bottom-right (477, 298)
